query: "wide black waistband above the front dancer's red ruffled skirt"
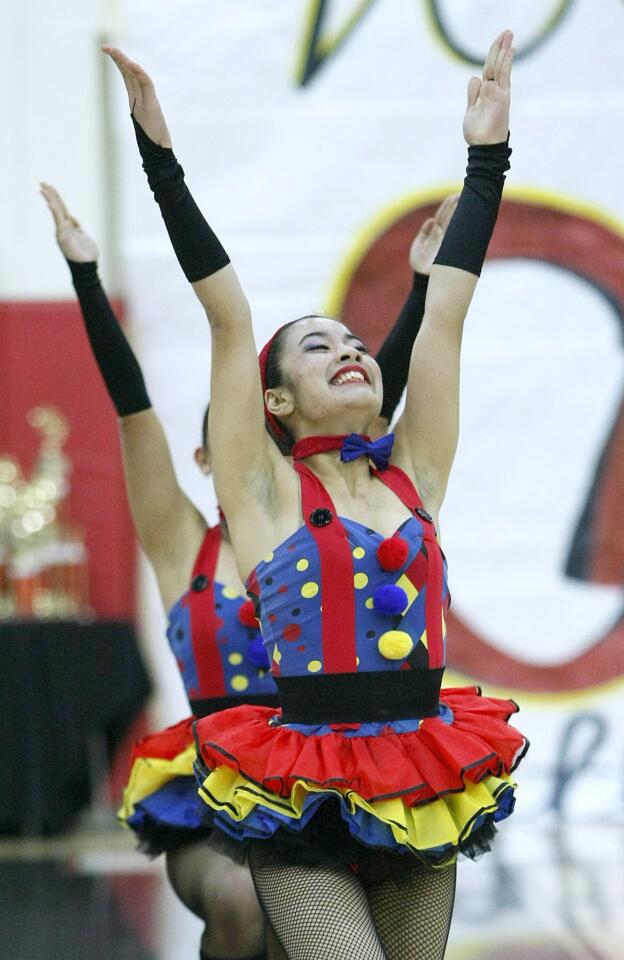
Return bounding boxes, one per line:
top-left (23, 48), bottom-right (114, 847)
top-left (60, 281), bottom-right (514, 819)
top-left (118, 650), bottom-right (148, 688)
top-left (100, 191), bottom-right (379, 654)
top-left (275, 668), bottom-right (444, 724)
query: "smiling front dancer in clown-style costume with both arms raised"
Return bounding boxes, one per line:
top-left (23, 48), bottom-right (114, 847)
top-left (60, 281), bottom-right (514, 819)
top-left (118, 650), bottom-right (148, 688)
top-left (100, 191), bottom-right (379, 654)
top-left (108, 31), bottom-right (526, 960)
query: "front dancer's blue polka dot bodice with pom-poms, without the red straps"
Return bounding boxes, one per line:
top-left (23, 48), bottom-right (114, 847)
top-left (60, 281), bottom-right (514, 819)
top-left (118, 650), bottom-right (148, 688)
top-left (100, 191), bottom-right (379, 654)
top-left (247, 517), bottom-right (449, 676)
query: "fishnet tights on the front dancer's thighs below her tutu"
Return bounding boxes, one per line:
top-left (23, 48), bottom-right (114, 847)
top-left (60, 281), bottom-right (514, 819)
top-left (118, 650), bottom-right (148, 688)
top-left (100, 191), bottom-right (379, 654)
top-left (250, 844), bottom-right (455, 960)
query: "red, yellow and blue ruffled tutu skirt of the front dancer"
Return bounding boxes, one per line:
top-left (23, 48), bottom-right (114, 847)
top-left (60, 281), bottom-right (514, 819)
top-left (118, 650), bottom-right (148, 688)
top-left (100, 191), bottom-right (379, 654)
top-left (194, 687), bottom-right (528, 866)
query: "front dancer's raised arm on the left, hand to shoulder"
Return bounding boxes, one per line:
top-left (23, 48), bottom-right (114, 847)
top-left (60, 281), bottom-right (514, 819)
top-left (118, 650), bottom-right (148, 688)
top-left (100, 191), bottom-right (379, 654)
top-left (103, 47), bottom-right (282, 528)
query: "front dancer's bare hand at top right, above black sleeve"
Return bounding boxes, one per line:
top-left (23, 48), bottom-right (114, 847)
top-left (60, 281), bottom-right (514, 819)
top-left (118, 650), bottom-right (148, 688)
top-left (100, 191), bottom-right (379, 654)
top-left (464, 30), bottom-right (514, 145)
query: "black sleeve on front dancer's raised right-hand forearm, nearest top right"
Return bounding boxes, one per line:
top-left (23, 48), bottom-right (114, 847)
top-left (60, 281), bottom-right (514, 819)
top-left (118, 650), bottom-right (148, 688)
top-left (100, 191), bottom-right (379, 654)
top-left (434, 142), bottom-right (511, 276)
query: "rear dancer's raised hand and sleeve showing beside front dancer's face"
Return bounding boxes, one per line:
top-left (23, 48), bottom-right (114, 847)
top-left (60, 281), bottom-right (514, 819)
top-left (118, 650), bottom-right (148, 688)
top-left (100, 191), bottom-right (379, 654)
top-left (373, 193), bottom-right (459, 436)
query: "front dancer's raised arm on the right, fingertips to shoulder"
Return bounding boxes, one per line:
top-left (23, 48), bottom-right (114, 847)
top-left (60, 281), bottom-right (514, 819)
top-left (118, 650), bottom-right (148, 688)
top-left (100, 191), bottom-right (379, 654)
top-left (396, 30), bottom-right (514, 513)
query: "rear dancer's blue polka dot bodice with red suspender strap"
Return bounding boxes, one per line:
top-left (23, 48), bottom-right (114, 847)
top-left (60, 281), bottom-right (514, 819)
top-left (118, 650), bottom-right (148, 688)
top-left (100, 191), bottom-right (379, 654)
top-left (167, 531), bottom-right (277, 702)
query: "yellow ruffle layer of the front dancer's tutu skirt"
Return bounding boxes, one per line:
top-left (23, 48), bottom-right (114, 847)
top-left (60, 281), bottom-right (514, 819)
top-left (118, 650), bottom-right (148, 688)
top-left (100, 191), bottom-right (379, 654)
top-left (199, 766), bottom-right (516, 852)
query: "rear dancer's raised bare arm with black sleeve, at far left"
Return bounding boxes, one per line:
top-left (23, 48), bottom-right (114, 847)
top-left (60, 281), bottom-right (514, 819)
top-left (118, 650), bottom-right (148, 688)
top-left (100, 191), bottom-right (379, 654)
top-left (41, 183), bottom-right (206, 606)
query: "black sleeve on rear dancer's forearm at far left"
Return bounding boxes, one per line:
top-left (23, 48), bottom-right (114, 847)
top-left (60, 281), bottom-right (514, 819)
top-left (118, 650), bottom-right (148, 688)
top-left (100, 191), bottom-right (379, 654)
top-left (67, 260), bottom-right (152, 417)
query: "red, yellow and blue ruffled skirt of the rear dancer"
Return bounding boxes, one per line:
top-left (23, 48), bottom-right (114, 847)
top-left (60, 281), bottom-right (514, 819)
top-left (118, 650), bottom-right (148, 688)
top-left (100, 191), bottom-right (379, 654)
top-left (118, 716), bottom-right (212, 856)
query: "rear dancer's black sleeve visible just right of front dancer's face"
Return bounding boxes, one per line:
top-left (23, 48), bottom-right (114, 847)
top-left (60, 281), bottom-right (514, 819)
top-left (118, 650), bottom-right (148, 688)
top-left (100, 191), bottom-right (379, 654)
top-left (376, 273), bottom-right (429, 423)
